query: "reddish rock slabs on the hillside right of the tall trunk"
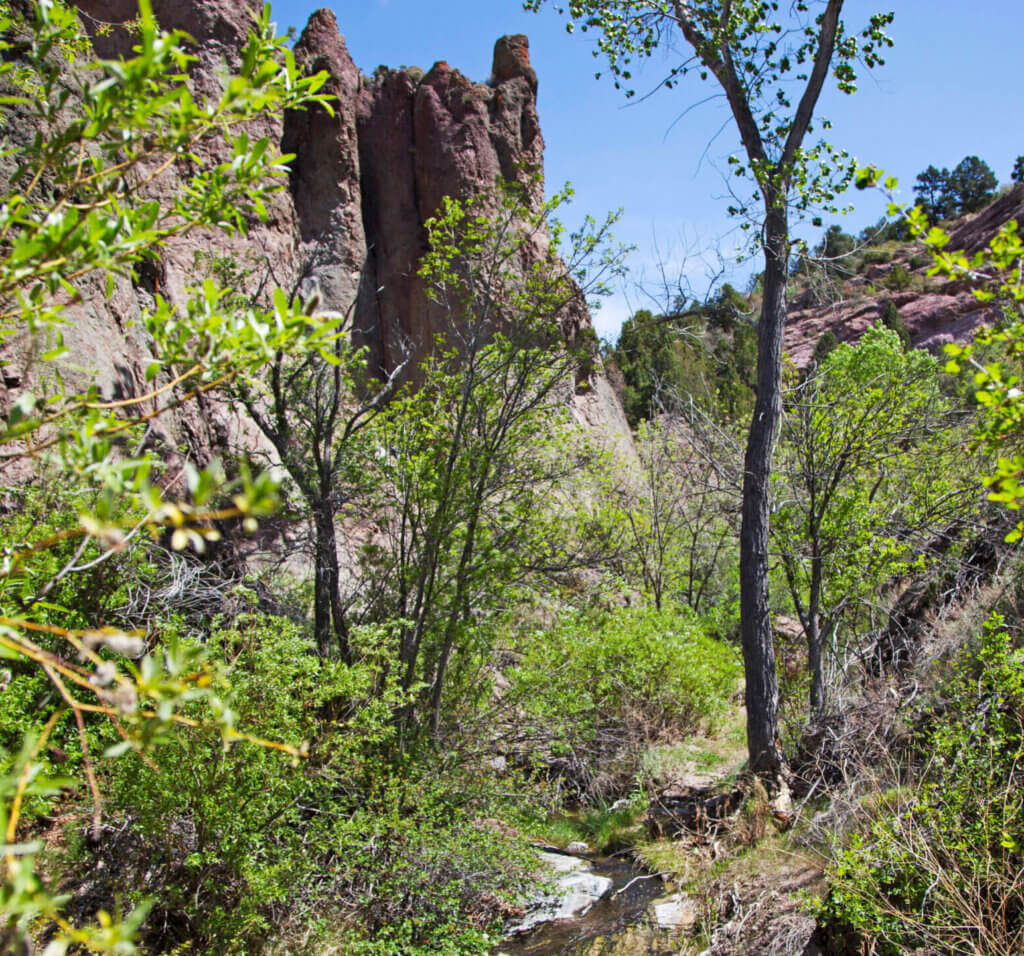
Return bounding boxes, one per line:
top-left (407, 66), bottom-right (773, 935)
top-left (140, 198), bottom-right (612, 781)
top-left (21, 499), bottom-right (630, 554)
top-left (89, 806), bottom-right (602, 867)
top-left (785, 184), bottom-right (1024, 367)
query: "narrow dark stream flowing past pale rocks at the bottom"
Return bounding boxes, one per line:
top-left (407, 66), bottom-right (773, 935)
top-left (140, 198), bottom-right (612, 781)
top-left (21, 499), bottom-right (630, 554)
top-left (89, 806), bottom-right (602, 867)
top-left (495, 858), bottom-right (665, 956)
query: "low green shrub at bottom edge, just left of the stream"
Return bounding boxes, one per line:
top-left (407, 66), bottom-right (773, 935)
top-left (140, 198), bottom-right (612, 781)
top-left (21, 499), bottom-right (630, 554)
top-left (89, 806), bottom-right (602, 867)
top-left (335, 767), bottom-right (537, 956)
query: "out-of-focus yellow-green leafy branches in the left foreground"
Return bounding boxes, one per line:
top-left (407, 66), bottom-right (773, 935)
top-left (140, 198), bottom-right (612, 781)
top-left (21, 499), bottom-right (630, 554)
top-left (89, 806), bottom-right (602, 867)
top-left (0, 0), bottom-right (332, 953)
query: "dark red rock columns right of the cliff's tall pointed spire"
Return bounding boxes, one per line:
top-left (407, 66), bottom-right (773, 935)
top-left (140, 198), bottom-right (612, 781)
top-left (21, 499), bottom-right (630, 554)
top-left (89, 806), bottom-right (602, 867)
top-left (344, 34), bottom-right (544, 367)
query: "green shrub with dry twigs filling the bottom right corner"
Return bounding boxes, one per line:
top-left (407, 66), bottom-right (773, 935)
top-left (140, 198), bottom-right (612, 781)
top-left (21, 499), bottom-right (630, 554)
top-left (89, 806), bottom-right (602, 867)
top-left (822, 616), bottom-right (1024, 954)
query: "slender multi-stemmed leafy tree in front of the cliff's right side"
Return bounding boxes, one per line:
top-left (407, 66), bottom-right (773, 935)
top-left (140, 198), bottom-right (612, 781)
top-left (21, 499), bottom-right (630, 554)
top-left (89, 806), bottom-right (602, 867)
top-left (367, 183), bottom-right (607, 748)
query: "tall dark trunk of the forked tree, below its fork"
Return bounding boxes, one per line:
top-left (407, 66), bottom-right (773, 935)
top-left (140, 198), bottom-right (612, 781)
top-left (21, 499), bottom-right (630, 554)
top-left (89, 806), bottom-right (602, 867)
top-left (739, 198), bottom-right (790, 776)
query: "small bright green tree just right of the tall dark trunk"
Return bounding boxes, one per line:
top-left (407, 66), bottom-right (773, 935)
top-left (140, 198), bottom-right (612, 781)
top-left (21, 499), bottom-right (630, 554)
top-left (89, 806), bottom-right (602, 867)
top-left (772, 325), bottom-right (972, 720)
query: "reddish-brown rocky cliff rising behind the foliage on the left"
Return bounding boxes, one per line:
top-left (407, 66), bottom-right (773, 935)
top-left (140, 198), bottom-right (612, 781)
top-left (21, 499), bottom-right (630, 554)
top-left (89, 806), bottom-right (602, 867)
top-left (24, 0), bottom-right (629, 460)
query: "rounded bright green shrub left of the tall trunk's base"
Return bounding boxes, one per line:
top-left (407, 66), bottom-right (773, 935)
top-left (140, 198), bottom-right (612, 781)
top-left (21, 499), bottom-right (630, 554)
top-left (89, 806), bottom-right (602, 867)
top-left (509, 608), bottom-right (740, 797)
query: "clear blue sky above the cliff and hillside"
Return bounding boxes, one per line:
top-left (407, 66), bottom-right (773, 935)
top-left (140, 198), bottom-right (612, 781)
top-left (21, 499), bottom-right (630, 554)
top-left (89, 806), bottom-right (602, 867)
top-left (273, 0), bottom-right (1024, 339)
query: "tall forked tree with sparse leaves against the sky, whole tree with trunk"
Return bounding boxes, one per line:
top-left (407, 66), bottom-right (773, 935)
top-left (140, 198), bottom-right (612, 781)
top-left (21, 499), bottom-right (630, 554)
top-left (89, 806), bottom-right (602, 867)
top-left (525, 0), bottom-right (892, 775)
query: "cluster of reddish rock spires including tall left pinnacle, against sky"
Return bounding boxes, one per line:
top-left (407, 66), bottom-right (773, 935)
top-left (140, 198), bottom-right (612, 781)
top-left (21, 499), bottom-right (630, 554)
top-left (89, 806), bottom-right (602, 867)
top-left (283, 10), bottom-right (552, 367)
